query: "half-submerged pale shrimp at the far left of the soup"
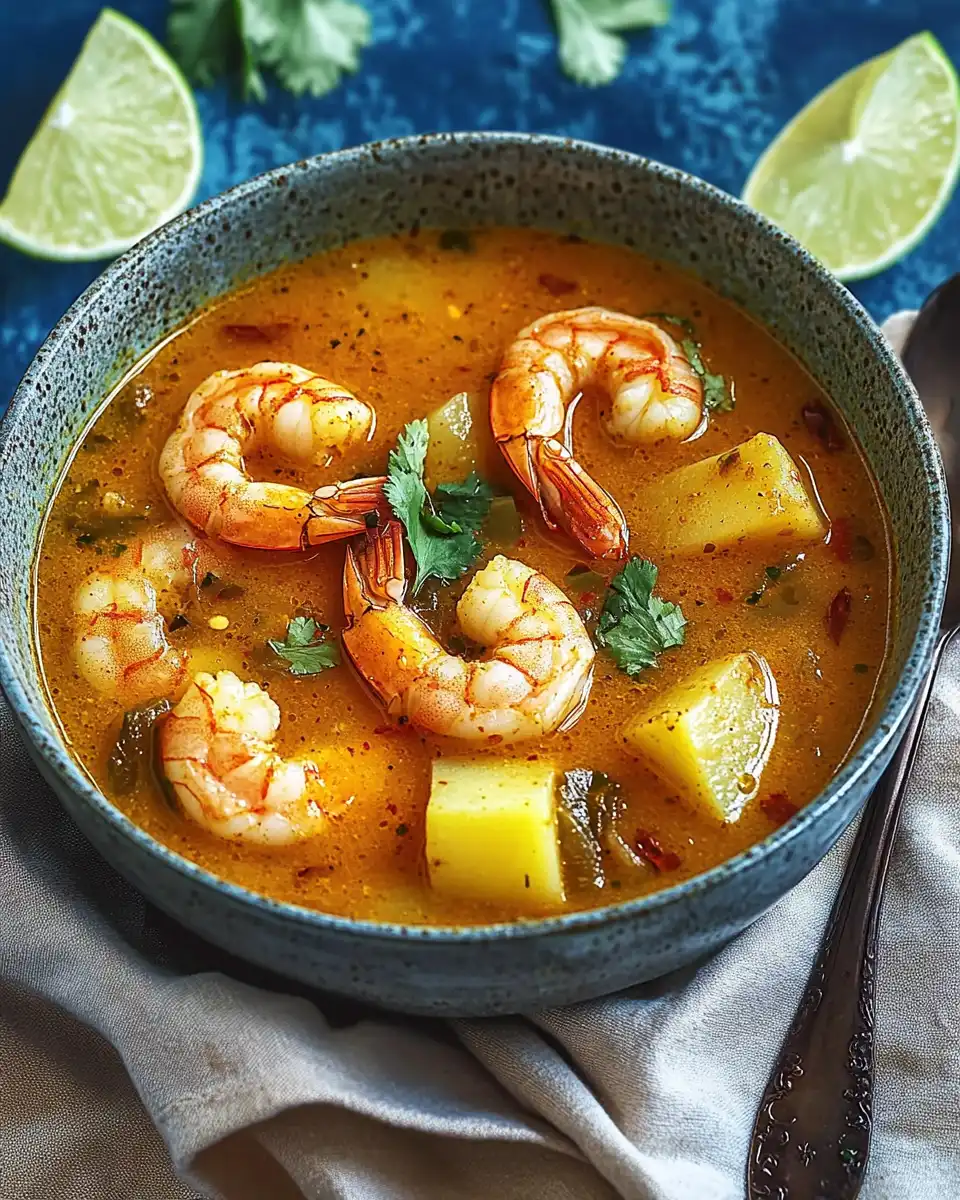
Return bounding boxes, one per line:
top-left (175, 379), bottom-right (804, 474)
top-left (73, 527), bottom-right (200, 703)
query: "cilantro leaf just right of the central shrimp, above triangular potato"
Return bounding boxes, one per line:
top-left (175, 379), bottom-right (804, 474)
top-left (596, 557), bottom-right (686, 674)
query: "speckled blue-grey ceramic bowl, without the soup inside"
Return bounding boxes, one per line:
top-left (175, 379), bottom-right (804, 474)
top-left (0, 133), bottom-right (948, 1015)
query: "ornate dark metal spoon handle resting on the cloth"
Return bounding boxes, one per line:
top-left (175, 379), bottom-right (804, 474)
top-left (746, 630), bottom-right (956, 1200)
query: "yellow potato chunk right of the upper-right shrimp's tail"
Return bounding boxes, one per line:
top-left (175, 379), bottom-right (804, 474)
top-left (640, 433), bottom-right (826, 554)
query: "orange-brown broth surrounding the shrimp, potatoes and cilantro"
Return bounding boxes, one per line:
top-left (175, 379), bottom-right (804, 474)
top-left (37, 229), bottom-right (890, 925)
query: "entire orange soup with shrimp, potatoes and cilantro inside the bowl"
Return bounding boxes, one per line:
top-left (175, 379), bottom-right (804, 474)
top-left (36, 229), bottom-right (890, 925)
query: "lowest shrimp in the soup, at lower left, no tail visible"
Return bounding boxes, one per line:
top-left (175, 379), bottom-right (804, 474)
top-left (160, 671), bottom-right (328, 846)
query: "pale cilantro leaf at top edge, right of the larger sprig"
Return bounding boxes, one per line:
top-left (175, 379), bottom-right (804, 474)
top-left (551, 0), bottom-right (670, 88)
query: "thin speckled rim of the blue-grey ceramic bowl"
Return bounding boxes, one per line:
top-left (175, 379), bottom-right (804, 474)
top-left (0, 131), bottom-right (950, 943)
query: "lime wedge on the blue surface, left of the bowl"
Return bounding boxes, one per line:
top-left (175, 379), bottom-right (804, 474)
top-left (0, 8), bottom-right (203, 260)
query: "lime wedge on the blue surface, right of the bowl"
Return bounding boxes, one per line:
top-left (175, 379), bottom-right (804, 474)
top-left (743, 34), bottom-right (960, 280)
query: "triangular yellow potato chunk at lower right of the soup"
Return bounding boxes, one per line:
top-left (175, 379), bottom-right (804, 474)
top-left (620, 653), bottom-right (780, 822)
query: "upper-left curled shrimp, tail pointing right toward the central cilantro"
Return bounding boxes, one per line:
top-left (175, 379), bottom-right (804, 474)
top-left (160, 362), bottom-right (385, 550)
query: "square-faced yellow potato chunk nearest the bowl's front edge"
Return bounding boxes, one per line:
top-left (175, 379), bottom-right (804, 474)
top-left (427, 758), bottom-right (564, 912)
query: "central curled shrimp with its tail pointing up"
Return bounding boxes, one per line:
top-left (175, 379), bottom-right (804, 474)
top-left (343, 521), bottom-right (594, 742)
